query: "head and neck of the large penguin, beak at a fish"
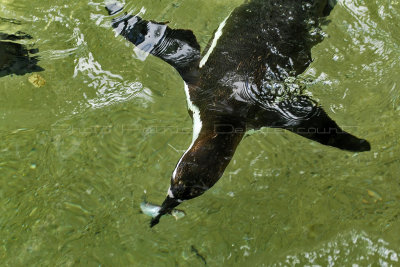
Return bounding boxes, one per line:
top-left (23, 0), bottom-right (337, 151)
top-left (150, 133), bottom-right (243, 227)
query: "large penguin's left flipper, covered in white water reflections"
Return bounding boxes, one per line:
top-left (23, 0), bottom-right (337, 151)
top-left (106, 4), bottom-right (200, 84)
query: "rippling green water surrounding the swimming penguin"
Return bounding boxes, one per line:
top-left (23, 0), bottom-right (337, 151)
top-left (0, 0), bottom-right (400, 266)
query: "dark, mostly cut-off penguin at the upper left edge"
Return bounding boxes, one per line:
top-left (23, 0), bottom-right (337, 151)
top-left (0, 28), bottom-right (44, 77)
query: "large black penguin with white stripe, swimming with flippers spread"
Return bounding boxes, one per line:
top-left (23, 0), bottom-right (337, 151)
top-left (106, 0), bottom-right (370, 226)
